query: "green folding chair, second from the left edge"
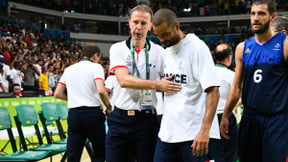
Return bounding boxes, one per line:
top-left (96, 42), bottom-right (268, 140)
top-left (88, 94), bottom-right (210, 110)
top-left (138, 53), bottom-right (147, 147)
top-left (14, 104), bottom-right (66, 161)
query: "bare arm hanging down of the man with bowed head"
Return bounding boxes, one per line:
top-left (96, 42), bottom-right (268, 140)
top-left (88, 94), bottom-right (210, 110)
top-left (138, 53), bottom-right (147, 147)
top-left (192, 86), bottom-right (219, 156)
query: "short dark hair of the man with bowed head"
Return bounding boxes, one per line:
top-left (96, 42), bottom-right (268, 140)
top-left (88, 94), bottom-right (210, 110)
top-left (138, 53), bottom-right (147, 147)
top-left (152, 8), bottom-right (178, 27)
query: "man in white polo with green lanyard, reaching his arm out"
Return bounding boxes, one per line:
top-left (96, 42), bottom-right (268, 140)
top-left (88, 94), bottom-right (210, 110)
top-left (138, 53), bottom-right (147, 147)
top-left (106, 5), bottom-right (181, 162)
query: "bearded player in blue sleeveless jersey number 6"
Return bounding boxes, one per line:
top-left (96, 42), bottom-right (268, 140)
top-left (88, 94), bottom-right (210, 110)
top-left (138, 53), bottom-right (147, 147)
top-left (220, 0), bottom-right (288, 162)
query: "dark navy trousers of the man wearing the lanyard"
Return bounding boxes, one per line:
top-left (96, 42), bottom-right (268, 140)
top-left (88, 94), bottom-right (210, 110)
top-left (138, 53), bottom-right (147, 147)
top-left (106, 107), bottom-right (158, 162)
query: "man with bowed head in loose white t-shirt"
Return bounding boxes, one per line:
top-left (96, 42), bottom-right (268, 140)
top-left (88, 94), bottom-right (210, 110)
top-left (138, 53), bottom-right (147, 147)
top-left (153, 9), bottom-right (220, 162)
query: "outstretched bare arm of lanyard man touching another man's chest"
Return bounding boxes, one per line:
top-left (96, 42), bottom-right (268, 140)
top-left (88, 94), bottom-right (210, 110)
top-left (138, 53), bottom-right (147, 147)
top-left (114, 68), bottom-right (181, 93)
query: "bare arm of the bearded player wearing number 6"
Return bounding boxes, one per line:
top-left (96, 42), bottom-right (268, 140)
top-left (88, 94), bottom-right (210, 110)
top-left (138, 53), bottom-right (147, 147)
top-left (220, 42), bottom-right (244, 139)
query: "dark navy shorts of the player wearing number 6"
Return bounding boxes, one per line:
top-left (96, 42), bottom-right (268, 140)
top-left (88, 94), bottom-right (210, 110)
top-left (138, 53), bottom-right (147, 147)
top-left (239, 109), bottom-right (288, 162)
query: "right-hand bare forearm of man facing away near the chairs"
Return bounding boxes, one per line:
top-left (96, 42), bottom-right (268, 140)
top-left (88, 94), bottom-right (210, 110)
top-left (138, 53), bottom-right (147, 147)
top-left (95, 79), bottom-right (111, 112)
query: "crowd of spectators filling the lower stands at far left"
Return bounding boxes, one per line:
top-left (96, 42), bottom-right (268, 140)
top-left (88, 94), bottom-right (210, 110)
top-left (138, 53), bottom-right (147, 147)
top-left (0, 21), bottom-right (107, 95)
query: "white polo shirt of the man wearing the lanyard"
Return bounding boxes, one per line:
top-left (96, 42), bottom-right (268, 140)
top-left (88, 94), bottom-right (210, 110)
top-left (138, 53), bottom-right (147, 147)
top-left (110, 40), bottom-right (165, 110)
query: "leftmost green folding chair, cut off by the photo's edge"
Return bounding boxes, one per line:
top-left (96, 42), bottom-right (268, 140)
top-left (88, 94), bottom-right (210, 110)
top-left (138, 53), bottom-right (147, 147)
top-left (0, 107), bottom-right (49, 161)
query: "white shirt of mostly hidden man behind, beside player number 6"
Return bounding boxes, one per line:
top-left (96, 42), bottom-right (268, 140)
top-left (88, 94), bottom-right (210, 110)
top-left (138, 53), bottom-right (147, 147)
top-left (216, 66), bottom-right (234, 114)
